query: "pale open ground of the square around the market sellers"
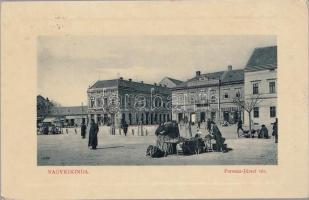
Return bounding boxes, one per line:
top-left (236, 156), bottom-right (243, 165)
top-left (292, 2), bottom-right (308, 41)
top-left (37, 126), bottom-right (277, 166)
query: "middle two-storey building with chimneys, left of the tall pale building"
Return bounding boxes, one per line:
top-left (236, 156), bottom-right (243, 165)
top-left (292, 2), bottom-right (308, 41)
top-left (171, 66), bottom-right (244, 123)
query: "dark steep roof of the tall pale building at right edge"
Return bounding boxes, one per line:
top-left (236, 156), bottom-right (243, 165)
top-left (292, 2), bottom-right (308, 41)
top-left (245, 46), bottom-right (277, 71)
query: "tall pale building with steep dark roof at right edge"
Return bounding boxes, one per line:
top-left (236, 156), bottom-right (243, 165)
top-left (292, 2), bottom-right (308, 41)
top-left (245, 46), bottom-right (277, 126)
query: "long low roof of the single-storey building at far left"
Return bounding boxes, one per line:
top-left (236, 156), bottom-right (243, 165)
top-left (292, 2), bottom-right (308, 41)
top-left (49, 106), bottom-right (88, 116)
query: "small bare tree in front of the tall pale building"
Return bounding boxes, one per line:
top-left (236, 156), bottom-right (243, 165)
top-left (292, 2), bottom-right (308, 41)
top-left (233, 94), bottom-right (262, 137)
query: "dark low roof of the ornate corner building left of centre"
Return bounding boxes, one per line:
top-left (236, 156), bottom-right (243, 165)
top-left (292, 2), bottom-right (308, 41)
top-left (90, 79), bottom-right (170, 94)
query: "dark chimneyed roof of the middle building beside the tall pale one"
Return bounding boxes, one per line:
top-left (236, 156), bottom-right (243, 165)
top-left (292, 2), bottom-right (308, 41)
top-left (173, 69), bottom-right (244, 89)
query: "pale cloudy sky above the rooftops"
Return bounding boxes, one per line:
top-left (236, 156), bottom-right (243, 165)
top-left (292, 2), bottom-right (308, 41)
top-left (37, 35), bottom-right (277, 106)
